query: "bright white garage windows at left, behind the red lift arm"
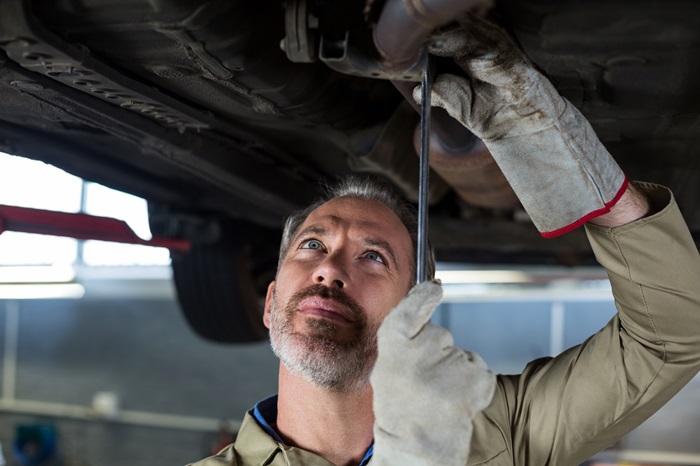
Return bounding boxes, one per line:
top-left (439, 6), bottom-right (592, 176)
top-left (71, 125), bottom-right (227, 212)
top-left (0, 153), bottom-right (170, 266)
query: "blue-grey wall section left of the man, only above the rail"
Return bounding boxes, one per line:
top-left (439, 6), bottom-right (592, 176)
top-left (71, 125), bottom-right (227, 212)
top-left (10, 300), bottom-right (277, 417)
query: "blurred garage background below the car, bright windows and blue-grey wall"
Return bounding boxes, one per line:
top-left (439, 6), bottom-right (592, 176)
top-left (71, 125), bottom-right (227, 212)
top-left (0, 154), bottom-right (700, 466)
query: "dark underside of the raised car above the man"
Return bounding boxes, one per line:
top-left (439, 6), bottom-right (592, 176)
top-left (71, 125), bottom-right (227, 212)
top-left (0, 0), bottom-right (700, 341)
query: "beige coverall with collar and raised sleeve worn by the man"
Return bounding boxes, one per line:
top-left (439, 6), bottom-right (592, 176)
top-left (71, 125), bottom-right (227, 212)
top-left (189, 183), bottom-right (700, 466)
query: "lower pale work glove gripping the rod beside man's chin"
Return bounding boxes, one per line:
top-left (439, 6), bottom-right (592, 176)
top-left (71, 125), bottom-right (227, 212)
top-left (370, 281), bottom-right (496, 466)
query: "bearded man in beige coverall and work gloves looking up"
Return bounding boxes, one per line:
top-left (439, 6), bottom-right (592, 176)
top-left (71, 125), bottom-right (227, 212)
top-left (190, 12), bottom-right (700, 466)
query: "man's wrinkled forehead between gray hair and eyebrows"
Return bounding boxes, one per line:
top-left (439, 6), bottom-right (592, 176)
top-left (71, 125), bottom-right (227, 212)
top-left (298, 197), bottom-right (413, 255)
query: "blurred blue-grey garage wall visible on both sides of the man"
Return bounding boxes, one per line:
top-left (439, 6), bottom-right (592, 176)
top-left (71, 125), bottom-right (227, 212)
top-left (0, 288), bottom-right (700, 466)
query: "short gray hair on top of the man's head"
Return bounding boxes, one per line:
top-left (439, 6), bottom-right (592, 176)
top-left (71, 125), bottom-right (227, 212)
top-left (277, 175), bottom-right (435, 285)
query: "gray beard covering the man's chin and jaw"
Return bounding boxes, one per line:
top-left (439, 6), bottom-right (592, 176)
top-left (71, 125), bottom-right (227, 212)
top-left (270, 291), bottom-right (377, 392)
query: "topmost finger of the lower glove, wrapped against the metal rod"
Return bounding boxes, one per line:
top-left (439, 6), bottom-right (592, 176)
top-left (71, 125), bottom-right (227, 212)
top-left (378, 280), bottom-right (442, 339)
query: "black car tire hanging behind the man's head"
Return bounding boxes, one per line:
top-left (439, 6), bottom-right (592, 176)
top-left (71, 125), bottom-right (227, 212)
top-left (172, 223), bottom-right (280, 343)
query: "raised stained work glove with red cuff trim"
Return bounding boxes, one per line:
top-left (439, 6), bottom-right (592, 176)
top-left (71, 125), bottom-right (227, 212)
top-left (413, 15), bottom-right (627, 237)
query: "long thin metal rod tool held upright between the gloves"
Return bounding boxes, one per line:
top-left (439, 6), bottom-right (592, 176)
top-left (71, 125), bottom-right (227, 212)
top-left (416, 55), bottom-right (433, 283)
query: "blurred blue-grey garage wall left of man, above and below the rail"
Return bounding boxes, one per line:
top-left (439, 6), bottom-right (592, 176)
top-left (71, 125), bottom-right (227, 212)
top-left (0, 298), bottom-right (277, 466)
